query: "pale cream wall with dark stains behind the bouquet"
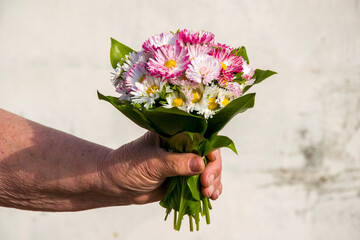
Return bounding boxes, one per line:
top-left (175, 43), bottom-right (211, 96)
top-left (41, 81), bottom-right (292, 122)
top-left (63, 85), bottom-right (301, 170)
top-left (0, 0), bottom-right (360, 240)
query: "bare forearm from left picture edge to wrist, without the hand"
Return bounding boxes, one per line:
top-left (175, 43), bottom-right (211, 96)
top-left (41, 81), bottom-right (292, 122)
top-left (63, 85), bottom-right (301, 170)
top-left (0, 109), bottom-right (119, 211)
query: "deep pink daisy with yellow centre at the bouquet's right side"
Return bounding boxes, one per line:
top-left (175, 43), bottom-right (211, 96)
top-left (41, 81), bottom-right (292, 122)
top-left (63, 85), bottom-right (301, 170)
top-left (210, 48), bottom-right (244, 81)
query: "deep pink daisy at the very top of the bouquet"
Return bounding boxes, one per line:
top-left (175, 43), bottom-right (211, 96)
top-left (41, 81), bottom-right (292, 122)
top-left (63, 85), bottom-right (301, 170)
top-left (178, 29), bottom-right (214, 45)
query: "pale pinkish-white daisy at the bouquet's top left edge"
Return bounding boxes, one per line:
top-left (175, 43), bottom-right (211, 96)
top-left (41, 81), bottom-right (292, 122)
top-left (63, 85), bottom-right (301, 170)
top-left (142, 32), bottom-right (178, 52)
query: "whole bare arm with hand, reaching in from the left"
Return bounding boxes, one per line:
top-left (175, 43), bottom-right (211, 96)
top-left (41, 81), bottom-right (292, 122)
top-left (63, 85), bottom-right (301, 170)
top-left (0, 109), bottom-right (222, 211)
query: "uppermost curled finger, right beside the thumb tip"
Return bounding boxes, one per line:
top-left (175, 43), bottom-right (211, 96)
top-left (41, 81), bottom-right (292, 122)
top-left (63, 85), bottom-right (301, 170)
top-left (200, 150), bottom-right (222, 187)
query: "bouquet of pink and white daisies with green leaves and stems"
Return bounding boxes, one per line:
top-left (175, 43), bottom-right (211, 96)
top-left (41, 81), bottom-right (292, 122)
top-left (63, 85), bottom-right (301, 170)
top-left (98, 29), bottom-right (275, 231)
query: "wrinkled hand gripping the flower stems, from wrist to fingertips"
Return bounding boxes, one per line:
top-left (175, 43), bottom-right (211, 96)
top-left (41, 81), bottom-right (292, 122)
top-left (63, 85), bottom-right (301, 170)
top-left (101, 132), bottom-right (222, 205)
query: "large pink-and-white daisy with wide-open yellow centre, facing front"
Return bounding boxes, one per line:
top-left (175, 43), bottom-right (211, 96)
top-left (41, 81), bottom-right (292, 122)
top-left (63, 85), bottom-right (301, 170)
top-left (148, 45), bottom-right (189, 79)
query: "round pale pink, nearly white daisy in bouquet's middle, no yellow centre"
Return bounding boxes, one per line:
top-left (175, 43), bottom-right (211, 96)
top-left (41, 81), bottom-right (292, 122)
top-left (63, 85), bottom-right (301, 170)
top-left (185, 55), bottom-right (221, 84)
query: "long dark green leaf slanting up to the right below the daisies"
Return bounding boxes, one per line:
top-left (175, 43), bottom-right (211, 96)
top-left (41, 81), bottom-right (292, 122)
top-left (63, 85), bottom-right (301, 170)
top-left (204, 93), bottom-right (255, 140)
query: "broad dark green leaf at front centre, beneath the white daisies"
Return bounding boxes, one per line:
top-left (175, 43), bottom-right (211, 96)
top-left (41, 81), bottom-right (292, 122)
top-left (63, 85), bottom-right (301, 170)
top-left (141, 107), bottom-right (207, 138)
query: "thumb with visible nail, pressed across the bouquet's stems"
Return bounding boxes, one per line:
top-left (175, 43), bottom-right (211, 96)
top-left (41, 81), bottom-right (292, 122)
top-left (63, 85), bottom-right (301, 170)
top-left (163, 153), bottom-right (205, 177)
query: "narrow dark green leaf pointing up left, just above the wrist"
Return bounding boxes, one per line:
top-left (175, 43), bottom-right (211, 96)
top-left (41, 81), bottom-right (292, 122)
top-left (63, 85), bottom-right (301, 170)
top-left (97, 91), bottom-right (154, 131)
